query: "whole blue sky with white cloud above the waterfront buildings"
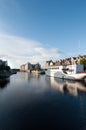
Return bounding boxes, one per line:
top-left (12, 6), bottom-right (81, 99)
top-left (0, 0), bottom-right (86, 68)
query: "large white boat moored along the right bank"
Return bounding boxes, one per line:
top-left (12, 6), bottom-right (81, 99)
top-left (46, 64), bottom-right (86, 81)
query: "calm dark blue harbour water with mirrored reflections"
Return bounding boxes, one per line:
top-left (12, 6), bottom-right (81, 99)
top-left (0, 72), bottom-right (86, 130)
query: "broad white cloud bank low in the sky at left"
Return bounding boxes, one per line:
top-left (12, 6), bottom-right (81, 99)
top-left (0, 34), bottom-right (60, 67)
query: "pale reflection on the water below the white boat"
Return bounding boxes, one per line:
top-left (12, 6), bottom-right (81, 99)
top-left (46, 77), bottom-right (86, 96)
